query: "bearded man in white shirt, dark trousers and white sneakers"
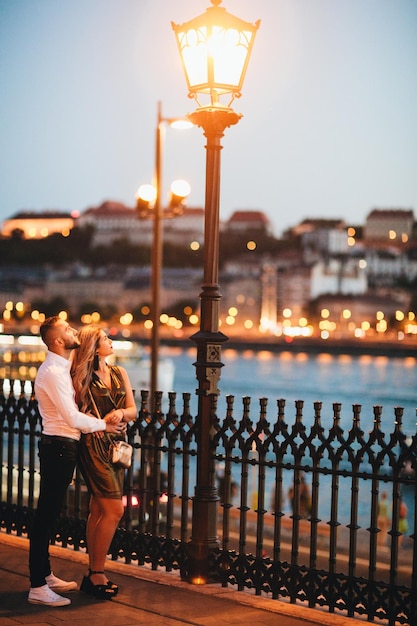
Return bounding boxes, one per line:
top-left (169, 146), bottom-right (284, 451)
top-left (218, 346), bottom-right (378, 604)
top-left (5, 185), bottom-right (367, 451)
top-left (28, 316), bottom-right (126, 606)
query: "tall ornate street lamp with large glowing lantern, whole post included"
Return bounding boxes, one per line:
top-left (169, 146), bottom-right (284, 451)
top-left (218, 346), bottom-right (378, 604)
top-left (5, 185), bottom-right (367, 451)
top-left (172, 0), bottom-right (260, 584)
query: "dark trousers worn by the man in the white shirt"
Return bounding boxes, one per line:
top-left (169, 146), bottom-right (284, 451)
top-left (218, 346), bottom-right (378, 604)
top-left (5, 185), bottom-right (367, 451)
top-left (29, 436), bottom-right (78, 587)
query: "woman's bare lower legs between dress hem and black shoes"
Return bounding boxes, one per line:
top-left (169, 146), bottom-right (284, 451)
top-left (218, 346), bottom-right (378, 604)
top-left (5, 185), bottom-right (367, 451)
top-left (86, 496), bottom-right (123, 585)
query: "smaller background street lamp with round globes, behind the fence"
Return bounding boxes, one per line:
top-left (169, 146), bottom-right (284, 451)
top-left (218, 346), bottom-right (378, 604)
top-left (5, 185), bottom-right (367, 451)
top-left (136, 102), bottom-right (191, 407)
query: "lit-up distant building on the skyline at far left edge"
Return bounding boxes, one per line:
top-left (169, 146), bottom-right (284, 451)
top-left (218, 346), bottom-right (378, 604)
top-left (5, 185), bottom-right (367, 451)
top-left (1, 211), bottom-right (75, 239)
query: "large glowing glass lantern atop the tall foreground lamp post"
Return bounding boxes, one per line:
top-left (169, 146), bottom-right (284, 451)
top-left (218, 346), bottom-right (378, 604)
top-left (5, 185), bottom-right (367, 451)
top-left (171, 0), bottom-right (260, 108)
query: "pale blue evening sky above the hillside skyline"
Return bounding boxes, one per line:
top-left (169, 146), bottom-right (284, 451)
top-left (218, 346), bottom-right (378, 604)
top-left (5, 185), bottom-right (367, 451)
top-left (0, 0), bottom-right (417, 235)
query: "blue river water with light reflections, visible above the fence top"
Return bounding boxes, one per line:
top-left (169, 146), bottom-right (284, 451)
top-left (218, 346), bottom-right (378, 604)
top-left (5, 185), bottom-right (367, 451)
top-left (161, 347), bottom-right (417, 436)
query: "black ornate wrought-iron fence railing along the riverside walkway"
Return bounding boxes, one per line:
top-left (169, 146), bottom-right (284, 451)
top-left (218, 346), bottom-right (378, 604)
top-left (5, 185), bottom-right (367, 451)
top-left (0, 381), bottom-right (417, 626)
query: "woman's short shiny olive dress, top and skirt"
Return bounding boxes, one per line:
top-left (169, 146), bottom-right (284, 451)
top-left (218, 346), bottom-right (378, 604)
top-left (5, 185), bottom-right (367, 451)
top-left (78, 366), bottom-right (126, 499)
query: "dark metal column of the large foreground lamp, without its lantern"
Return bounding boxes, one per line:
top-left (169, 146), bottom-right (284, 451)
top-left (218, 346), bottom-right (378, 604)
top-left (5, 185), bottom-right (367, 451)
top-left (187, 108), bottom-right (240, 584)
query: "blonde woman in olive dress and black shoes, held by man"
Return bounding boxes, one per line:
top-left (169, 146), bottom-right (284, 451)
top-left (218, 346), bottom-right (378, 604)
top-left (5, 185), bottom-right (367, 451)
top-left (71, 326), bottom-right (137, 600)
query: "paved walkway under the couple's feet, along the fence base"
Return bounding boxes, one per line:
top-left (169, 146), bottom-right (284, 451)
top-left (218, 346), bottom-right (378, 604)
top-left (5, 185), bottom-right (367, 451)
top-left (0, 532), bottom-right (363, 626)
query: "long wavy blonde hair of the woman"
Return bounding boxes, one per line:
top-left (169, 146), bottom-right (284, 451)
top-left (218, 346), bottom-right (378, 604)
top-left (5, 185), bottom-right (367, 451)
top-left (71, 325), bottom-right (101, 411)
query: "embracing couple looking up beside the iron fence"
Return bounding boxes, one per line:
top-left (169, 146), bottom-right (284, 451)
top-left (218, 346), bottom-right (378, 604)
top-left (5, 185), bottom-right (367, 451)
top-left (28, 316), bottom-right (137, 606)
